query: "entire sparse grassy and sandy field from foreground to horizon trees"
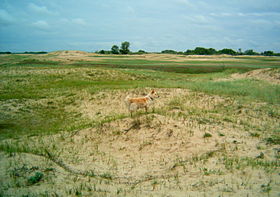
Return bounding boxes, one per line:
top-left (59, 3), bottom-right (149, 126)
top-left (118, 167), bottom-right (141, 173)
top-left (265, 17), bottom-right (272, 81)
top-left (0, 51), bottom-right (280, 197)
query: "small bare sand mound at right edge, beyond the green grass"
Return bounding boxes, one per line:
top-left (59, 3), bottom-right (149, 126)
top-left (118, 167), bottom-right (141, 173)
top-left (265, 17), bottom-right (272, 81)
top-left (232, 68), bottom-right (280, 84)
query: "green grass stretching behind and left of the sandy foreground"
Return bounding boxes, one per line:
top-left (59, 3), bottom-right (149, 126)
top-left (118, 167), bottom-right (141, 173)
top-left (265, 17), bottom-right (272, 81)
top-left (0, 55), bottom-right (280, 139)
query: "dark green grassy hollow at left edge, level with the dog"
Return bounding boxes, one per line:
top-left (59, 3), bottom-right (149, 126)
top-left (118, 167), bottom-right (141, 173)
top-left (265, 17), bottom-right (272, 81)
top-left (0, 99), bottom-right (82, 139)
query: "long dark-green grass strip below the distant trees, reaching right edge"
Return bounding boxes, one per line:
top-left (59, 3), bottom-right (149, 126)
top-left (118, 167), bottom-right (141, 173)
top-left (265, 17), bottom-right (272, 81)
top-left (74, 58), bottom-right (280, 74)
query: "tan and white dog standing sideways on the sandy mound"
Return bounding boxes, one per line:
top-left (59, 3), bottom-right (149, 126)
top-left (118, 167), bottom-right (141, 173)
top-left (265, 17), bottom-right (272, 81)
top-left (124, 90), bottom-right (159, 116)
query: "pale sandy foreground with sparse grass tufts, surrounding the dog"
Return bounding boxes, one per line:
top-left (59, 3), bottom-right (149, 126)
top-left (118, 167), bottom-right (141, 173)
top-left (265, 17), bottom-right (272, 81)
top-left (0, 89), bottom-right (280, 196)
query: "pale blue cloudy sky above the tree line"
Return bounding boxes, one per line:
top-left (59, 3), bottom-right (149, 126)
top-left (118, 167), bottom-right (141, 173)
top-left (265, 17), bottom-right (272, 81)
top-left (0, 0), bottom-right (280, 52)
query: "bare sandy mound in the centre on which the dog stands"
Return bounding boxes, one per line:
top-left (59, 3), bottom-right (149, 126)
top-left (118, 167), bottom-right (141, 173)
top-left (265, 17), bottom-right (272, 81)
top-left (60, 89), bottom-right (243, 181)
